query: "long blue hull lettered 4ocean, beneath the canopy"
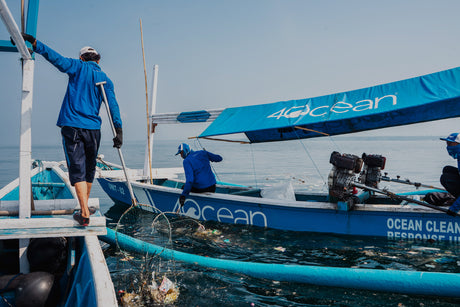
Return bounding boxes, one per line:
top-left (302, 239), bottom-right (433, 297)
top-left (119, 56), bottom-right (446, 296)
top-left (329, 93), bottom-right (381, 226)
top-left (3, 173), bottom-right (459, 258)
top-left (98, 178), bottom-right (460, 243)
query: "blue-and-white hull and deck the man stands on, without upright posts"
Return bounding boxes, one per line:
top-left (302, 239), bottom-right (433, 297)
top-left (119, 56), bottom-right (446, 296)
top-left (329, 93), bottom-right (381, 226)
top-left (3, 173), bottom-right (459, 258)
top-left (0, 160), bottom-right (117, 306)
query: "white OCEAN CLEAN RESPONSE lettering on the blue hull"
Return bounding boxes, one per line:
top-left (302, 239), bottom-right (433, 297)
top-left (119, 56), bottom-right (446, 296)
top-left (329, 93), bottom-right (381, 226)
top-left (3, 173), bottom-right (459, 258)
top-left (386, 218), bottom-right (460, 242)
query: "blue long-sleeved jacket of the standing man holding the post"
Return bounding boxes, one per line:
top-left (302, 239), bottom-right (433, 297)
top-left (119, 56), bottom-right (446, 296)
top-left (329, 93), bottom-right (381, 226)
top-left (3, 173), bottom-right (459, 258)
top-left (35, 40), bottom-right (121, 130)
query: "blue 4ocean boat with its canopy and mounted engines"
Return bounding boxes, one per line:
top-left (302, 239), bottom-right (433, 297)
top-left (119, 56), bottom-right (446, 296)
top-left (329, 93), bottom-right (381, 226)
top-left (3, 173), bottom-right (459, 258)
top-left (98, 68), bottom-right (460, 242)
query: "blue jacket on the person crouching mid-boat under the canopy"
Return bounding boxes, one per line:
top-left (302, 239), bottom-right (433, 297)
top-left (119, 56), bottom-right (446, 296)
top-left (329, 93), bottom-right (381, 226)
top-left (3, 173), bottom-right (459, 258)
top-left (182, 150), bottom-right (222, 196)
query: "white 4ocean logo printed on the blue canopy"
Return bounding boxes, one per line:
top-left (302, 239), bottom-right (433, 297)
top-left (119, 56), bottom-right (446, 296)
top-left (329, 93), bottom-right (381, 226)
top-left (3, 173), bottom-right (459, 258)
top-left (267, 95), bottom-right (397, 119)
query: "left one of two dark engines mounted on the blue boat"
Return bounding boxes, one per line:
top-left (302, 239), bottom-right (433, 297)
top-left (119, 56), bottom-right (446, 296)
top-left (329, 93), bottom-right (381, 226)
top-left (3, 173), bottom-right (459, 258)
top-left (328, 151), bottom-right (363, 201)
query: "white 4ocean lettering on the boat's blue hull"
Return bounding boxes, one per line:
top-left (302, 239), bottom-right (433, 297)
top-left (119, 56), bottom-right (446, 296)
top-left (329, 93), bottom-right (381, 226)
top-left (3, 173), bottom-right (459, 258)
top-left (173, 198), bottom-right (267, 227)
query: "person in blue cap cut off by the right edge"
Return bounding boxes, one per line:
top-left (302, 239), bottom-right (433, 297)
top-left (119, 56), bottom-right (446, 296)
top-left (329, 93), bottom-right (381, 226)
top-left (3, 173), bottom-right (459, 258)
top-left (425, 133), bottom-right (460, 216)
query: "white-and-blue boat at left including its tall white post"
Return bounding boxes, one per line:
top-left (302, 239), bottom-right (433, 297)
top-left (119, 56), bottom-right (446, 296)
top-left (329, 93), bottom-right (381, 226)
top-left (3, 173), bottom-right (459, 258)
top-left (0, 0), bottom-right (117, 307)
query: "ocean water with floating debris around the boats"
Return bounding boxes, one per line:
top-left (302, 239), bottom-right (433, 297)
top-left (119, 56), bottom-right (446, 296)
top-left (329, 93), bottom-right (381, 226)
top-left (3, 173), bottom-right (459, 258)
top-left (0, 136), bottom-right (460, 306)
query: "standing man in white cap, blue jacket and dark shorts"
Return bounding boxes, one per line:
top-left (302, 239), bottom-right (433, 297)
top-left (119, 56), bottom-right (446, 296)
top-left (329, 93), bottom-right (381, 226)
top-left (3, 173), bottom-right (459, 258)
top-left (22, 34), bottom-right (123, 226)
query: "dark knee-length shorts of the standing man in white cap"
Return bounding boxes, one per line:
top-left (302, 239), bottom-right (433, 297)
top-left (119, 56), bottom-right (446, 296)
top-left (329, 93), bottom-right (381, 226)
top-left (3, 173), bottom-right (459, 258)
top-left (61, 126), bottom-right (101, 185)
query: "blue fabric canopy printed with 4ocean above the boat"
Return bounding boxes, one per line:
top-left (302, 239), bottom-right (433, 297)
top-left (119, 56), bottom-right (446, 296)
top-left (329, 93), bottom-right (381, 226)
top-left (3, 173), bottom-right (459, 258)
top-left (199, 67), bottom-right (460, 143)
